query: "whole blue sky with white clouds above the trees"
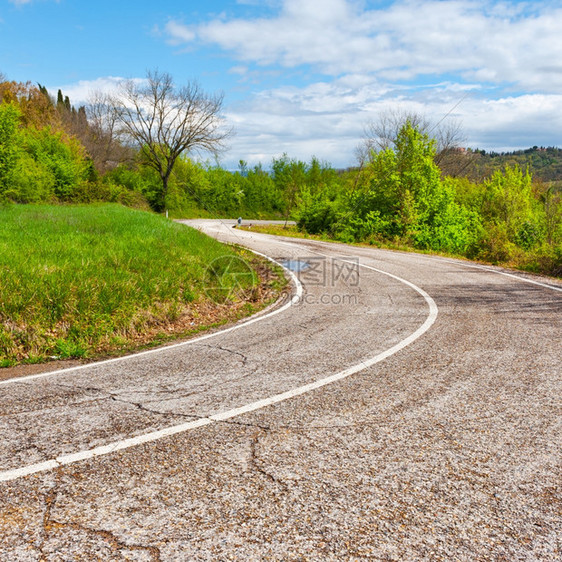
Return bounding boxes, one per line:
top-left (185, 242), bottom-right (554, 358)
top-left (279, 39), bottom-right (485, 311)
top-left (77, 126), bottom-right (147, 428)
top-left (0, 0), bottom-right (562, 167)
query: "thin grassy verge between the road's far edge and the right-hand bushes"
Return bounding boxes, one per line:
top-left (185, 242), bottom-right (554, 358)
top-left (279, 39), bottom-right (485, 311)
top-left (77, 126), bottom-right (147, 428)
top-left (241, 225), bottom-right (562, 278)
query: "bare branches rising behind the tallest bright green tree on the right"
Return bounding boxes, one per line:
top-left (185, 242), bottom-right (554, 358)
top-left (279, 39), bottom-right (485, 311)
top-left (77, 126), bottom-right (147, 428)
top-left (356, 108), bottom-right (474, 176)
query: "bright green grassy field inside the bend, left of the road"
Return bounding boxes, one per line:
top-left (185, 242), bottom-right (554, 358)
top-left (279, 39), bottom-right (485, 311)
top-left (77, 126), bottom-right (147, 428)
top-left (0, 205), bottom-right (285, 367)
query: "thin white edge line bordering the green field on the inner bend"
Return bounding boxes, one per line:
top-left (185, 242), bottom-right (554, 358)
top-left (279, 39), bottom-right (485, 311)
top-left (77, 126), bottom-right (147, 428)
top-left (0, 248), bottom-right (303, 386)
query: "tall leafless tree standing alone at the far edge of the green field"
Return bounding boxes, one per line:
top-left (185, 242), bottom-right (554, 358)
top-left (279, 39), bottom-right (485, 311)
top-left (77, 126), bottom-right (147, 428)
top-left (110, 70), bottom-right (229, 211)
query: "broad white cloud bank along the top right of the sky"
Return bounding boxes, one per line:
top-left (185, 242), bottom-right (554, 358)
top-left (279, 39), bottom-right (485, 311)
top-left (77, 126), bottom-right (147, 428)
top-left (166, 0), bottom-right (562, 91)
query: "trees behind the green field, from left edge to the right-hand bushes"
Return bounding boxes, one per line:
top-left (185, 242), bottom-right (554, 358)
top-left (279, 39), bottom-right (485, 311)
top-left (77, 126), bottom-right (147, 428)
top-left (0, 72), bottom-right (344, 218)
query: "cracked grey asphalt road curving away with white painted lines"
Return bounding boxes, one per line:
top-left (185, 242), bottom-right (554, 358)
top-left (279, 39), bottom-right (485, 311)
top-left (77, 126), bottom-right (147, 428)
top-left (0, 221), bottom-right (562, 561)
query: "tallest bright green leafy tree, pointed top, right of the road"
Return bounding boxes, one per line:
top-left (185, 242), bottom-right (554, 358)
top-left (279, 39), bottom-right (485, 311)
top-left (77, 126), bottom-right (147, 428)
top-left (316, 123), bottom-right (480, 252)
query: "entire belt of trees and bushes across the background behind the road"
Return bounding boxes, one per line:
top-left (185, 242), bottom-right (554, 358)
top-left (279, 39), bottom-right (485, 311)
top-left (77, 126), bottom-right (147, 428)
top-left (0, 72), bottom-right (562, 274)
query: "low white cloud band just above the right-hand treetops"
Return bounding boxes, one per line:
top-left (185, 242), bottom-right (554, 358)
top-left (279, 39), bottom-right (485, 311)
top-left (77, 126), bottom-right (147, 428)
top-left (220, 77), bottom-right (562, 167)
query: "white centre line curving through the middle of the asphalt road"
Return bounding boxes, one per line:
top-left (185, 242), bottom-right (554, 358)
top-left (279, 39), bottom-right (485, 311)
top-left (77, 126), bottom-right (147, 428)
top-left (0, 256), bottom-right (438, 482)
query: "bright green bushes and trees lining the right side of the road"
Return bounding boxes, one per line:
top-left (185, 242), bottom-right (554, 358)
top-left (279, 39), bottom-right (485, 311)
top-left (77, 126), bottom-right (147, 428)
top-left (298, 124), bottom-right (562, 276)
